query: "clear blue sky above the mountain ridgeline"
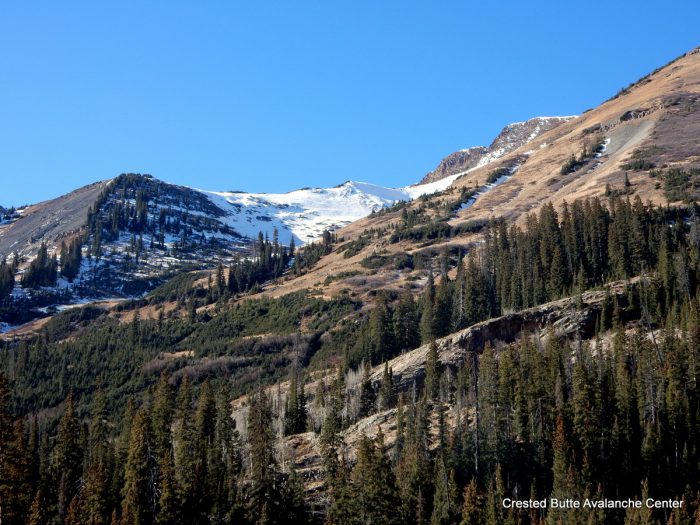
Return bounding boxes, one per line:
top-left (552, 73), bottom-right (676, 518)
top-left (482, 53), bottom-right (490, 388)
top-left (0, 0), bottom-right (700, 205)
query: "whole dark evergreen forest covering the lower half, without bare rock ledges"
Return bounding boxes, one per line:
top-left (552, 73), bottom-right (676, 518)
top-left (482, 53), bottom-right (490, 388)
top-left (0, 195), bottom-right (700, 525)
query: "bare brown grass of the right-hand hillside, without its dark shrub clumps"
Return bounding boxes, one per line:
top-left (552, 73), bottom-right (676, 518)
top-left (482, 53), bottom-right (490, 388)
top-left (265, 49), bottom-right (700, 302)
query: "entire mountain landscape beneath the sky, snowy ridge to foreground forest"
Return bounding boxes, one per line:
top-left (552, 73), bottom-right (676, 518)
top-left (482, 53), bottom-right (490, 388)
top-left (0, 46), bottom-right (700, 524)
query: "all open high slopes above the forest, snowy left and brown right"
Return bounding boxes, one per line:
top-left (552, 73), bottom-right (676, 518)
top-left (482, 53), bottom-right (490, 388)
top-left (5, 51), bottom-right (700, 328)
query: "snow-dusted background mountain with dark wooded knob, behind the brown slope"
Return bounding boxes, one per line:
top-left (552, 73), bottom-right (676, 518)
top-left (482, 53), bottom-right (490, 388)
top-left (0, 111), bottom-right (566, 303)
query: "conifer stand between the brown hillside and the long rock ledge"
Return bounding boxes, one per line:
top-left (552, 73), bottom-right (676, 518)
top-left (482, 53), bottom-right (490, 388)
top-left (338, 196), bottom-right (700, 367)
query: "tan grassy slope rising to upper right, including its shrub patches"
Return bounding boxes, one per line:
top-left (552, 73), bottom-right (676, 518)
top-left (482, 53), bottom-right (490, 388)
top-left (268, 50), bottom-right (700, 295)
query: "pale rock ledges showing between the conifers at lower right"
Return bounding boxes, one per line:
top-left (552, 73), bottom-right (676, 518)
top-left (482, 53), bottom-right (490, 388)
top-left (262, 278), bottom-right (639, 498)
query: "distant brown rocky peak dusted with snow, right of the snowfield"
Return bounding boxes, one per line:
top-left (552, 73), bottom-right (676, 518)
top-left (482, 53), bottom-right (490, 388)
top-left (420, 117), bottom-right (575, 184)
